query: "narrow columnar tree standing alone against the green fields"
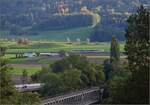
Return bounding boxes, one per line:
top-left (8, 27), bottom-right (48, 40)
top-left (110, 36), bottom-right (120, 62)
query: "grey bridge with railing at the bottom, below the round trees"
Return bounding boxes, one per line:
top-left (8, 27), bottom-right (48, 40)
top-left (42, 87), bottom-right (104, 105)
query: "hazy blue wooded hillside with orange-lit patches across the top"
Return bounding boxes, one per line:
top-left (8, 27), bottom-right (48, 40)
top-left (0, 0), bottom-right (150, 41)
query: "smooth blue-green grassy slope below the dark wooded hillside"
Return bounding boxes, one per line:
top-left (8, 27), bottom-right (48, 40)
top-left (0, 27), bottom-right (94, 41)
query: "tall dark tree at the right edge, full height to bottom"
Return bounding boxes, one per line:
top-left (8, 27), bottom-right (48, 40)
top-left (125, 6), bottom-right (150, 104)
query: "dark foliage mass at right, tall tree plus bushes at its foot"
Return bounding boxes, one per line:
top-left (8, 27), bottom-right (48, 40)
top-left (106, 6), bottom-right (150, 104)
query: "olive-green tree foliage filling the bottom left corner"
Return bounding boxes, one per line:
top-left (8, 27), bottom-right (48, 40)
top-left (0, 47), bottom-right (40, 105)
